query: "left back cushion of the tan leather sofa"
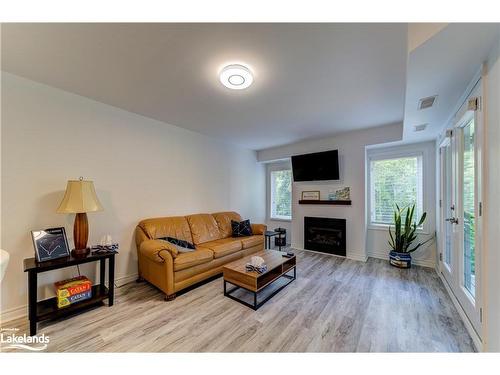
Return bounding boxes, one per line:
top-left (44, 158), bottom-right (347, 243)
top-left (139, 216), bottom-right (193, 243)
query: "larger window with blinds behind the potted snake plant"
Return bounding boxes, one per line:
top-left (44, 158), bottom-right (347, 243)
top-left (370, 155), bottom-right (423, 225)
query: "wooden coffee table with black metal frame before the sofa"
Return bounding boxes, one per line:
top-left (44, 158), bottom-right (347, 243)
top-left (222, 250), bottom-right (297, 310)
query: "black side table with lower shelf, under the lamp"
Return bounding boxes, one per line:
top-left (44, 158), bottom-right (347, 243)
top-left (24, 253), bottom-right (117, 336)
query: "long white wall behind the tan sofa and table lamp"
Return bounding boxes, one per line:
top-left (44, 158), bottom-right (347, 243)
top-left (1, 74), bottom-right (265, 319)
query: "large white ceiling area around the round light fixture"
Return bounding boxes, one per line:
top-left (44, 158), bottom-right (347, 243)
top-left (2, 24), bottom-right (407, 150)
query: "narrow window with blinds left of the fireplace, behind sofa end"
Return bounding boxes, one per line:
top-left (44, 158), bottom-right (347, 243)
top-left (270, 169), bottom-right (292, 220)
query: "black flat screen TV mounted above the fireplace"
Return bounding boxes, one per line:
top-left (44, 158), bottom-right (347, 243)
top-left (292, 150), bottom-right (339, 181)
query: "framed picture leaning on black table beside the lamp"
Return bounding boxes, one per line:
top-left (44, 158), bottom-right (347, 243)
top-left (31, 227), bottom-right (69, 262)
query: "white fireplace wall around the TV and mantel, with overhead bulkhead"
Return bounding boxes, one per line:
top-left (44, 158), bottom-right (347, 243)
top-left (257, 124), bottom-right (403, 260)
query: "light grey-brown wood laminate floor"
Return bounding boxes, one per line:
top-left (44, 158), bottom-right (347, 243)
top-left (3, 250), bottom-right (474, 352)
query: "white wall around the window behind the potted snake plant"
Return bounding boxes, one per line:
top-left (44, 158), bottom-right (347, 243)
top-left (366, 142), bottom-right (436, 267)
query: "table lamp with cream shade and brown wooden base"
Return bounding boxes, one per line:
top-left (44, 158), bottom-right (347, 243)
top-left (57, 177), bottom-right (103, 257)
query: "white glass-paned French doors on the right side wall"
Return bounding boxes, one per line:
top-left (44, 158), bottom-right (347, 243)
top-left (440, 88), bottom-right (482, 336)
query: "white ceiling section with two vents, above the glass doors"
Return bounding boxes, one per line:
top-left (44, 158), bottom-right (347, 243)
top-left (403, 23), bottom-right (500, 142)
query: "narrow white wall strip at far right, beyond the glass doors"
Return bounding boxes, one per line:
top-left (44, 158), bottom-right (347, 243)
top-left (483, 31), bottom-right (500, 352)
